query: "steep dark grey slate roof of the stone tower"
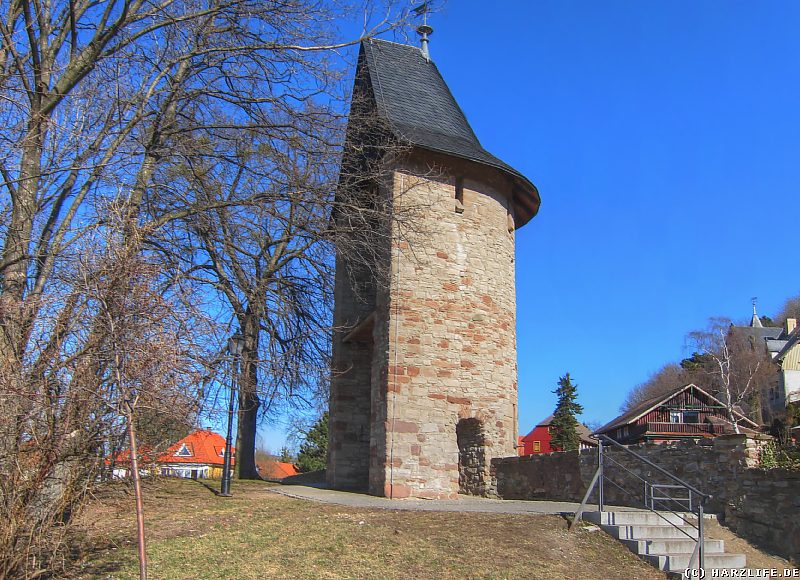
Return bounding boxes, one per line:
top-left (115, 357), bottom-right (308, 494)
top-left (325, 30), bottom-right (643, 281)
top-left (359, 39), bottom-right (540, 227)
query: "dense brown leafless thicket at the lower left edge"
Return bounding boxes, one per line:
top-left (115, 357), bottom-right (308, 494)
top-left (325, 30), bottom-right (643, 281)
top-left (0, 216), bottom-right (202, 577)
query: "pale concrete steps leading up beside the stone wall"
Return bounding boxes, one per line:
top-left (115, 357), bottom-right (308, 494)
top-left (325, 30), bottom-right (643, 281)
top-left (583, 510), bottom-right (745, 578)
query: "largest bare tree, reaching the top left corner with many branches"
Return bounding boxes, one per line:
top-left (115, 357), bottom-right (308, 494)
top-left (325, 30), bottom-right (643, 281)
top-left (0, 0), bottom-right (416, 575)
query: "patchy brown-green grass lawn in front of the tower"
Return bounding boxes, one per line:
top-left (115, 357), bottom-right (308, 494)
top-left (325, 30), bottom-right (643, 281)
top-left (69, 480), bottom-right (665, 579)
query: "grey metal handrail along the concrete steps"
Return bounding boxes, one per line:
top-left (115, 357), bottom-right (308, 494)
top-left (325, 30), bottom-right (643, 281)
top-left (570, 435), bottom-right (713, 569)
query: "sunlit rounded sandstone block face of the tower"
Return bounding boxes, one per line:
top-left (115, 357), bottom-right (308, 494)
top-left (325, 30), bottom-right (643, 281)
top-left (370, 155), bottom-right (517, 498)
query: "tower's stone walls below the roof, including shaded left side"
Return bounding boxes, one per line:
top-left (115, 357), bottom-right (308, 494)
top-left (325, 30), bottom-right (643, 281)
top-left (328, 154), bottom-right (517, 498)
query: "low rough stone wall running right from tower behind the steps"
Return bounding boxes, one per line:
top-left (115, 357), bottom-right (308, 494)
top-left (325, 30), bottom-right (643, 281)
top-left (491, 435), bottom-right (800, 562)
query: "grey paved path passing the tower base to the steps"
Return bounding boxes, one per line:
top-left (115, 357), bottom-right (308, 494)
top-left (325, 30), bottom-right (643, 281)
top-left (270, 485), bottom-right (591, 514)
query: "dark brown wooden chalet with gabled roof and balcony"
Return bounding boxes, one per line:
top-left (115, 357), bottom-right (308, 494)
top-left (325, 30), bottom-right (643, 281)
top-left (596, 384), bottom-right (758, 444)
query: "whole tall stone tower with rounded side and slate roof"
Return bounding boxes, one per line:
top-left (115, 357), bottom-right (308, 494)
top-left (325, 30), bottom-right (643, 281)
top-left (327, 40), bottom-right (540, 498)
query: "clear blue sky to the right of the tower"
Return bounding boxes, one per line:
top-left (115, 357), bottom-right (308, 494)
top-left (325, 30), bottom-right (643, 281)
top-left (264, 0), bottom-right (800, 449)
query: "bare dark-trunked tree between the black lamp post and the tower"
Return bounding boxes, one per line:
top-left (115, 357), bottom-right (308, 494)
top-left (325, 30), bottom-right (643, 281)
top-left (158, 126), bottom-right (335, 478)
